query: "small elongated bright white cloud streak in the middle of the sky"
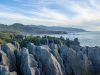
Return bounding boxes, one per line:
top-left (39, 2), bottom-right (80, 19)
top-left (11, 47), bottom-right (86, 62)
top-left (30, 8), bottom-right (68, 21)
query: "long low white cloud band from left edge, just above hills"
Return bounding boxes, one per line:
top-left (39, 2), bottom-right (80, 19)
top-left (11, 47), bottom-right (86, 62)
top-left (0, 11), bottom-right (69, 25)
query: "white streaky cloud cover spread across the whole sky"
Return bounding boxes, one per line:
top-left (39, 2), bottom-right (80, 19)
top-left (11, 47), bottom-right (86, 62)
top-left (0, 0), bottom-right (100, 30)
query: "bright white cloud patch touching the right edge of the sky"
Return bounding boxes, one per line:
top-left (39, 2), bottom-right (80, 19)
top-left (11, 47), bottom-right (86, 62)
top-left (61, 2), bottom-right (100, 28)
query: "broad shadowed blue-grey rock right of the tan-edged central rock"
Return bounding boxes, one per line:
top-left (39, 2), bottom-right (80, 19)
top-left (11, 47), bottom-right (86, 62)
top-left (61, 47), bottom-right (94, 75)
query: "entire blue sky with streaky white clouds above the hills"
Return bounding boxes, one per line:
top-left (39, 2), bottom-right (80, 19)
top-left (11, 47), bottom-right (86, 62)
top-left (0, 0), bottom-right (100, 31)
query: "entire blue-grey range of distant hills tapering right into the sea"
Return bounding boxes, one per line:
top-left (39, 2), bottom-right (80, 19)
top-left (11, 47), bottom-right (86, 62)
top-left (0, 23), bottom-right (85, 34)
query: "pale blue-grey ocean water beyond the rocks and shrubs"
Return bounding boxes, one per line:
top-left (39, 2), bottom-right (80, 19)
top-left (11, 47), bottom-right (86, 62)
top-left (33, 32), bottom-right (100, 47)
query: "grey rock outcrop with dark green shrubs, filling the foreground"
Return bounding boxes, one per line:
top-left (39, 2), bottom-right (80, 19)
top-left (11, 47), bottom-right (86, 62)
top-left (0, 32), bottom-right (100, 75)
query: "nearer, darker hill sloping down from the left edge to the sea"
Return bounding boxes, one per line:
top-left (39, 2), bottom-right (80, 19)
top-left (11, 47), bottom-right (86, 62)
top-left (0, 23), bottom-right (67, 34)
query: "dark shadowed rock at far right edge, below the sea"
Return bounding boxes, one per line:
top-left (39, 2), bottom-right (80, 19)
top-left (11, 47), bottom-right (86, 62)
top-left (87, 47), bottom-right (100, 75)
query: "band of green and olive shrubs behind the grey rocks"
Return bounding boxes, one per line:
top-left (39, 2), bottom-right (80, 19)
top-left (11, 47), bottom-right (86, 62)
top-left (0, 32), bottom-right (80, 47)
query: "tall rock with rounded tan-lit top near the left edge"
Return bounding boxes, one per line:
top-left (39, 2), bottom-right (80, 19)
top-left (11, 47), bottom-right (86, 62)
top-left (1, 43), bottom-right (16, 72)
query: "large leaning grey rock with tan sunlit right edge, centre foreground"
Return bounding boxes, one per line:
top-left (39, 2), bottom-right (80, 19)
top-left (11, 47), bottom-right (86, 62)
top-left (36, 46), bottom-right (63, 75)
